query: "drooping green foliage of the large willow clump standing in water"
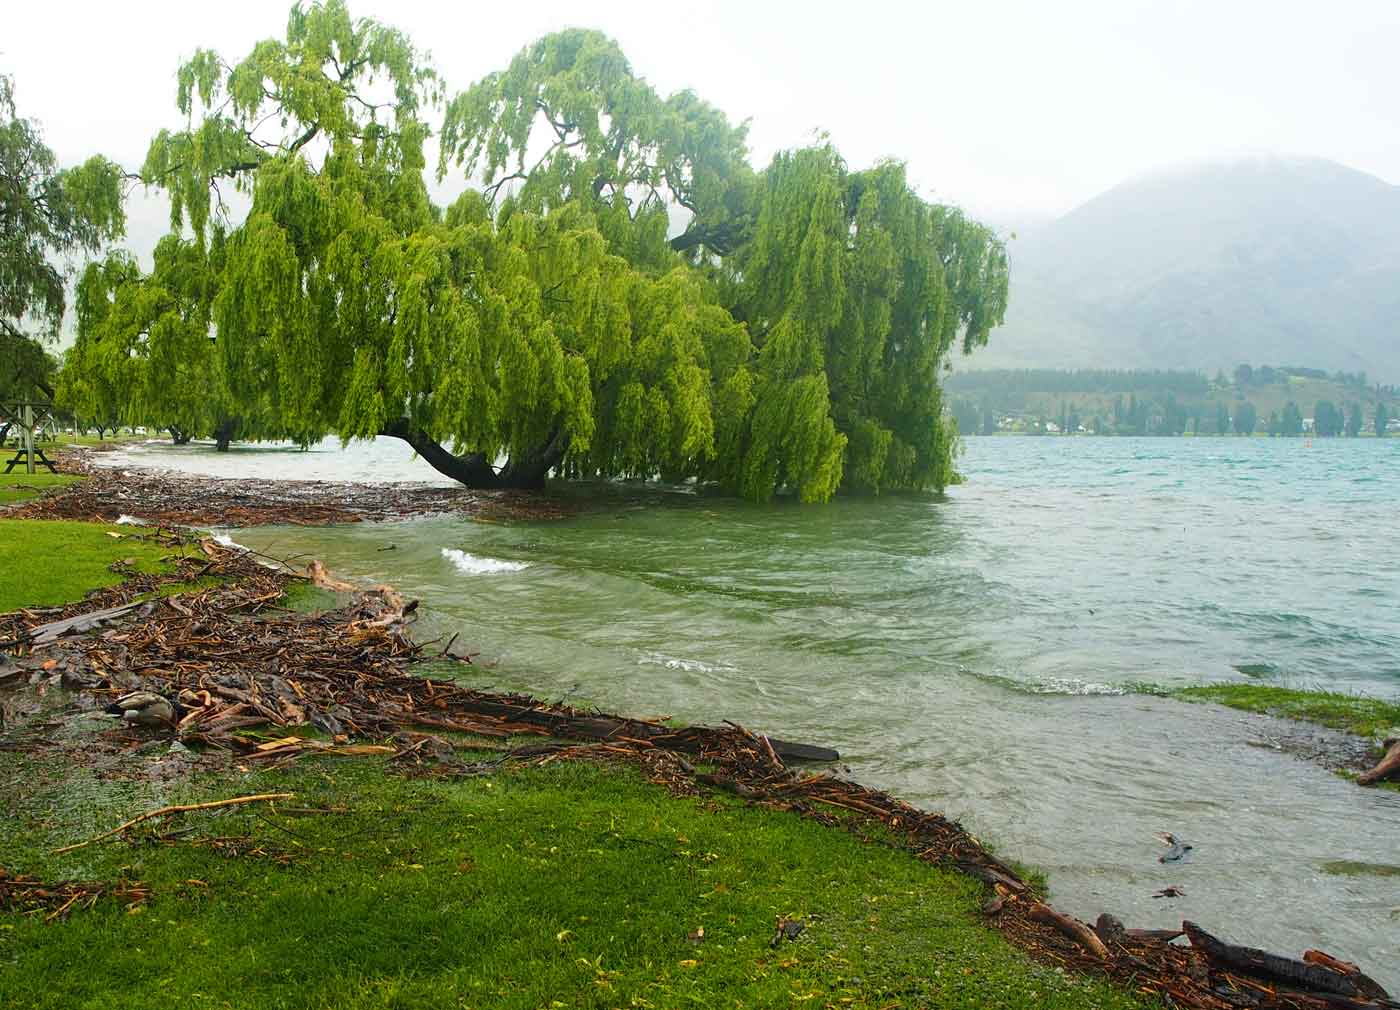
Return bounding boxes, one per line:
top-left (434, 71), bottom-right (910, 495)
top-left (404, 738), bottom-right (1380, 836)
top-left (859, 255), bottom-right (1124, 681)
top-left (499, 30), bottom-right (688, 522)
top-left (63, 0), bottom-right (1007, 501)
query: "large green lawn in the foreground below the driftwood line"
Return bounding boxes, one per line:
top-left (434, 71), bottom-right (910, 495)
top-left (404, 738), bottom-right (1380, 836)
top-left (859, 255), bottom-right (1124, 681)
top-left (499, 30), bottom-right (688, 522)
top-left (0, 752), bottom-right (1141, 1010)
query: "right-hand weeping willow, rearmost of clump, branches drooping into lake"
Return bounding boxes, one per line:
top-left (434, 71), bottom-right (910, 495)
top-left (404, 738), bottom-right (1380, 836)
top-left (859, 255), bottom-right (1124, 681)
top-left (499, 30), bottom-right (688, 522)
top-left (440, 29), bottom-right (1008, 501)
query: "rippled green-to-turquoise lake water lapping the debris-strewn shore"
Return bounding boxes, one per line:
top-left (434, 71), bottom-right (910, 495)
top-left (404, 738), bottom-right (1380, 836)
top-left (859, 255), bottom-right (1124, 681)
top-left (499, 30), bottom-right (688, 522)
top-left (98, 437), bottom-right (1400, 986)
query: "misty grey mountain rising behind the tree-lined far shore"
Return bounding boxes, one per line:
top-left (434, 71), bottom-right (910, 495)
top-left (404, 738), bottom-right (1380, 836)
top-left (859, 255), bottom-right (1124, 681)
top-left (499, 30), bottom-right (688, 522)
top-left (960, 157), bottom-right (1400, 382)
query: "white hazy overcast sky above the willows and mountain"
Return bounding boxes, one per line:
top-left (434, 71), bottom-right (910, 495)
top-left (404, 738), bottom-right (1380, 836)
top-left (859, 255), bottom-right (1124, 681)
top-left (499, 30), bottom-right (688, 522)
top-left (0, 0), bottom-right (1400, 224)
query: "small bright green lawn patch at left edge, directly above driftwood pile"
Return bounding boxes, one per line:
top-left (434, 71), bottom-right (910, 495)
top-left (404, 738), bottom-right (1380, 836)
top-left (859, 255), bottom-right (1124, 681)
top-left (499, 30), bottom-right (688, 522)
top-left (0, 518), bottom-right (179, 614)
